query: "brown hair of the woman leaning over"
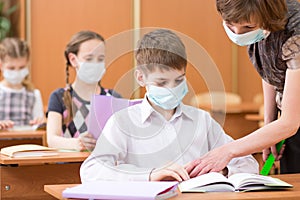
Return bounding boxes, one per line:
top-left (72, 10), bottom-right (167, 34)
top-left (216, 0), bottom-right (287, 32)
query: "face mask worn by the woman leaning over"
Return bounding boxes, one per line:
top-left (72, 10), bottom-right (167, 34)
top-left (223, 22), bottom-right (268, 46)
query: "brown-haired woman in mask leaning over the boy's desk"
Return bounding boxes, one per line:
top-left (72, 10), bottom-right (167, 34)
top-left (189, 0), bottom-right (300, 175)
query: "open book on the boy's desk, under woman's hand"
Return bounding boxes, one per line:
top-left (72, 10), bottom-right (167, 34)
top-left (179, 172), bottom-right (293, 192)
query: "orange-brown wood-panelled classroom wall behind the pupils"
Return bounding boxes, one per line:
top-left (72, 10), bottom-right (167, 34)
top-left (30, 0), bottom-right (261, 107)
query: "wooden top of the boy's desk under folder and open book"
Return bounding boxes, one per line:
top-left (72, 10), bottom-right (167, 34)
top-left (44, 174), bottom-right (300, 200)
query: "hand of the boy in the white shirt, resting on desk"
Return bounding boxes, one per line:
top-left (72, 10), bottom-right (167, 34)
top-left (150, 163), bottom-right (190, 181)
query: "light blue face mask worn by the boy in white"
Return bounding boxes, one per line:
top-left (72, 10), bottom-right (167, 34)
top-left (147, 80), bottom-right (188, 110)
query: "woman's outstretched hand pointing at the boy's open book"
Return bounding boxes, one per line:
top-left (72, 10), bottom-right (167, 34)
top-left (184, 146), bottom-right (232, 178)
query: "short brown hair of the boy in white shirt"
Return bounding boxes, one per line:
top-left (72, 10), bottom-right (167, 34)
top-left (135, 29), bottom-right (187, 72)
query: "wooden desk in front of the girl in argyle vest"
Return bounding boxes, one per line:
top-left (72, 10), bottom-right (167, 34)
top-left (0, 152), bottom-right (90, 200)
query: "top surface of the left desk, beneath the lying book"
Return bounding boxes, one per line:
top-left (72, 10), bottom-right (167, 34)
top-left (0, 152), bottom-right (90, 165)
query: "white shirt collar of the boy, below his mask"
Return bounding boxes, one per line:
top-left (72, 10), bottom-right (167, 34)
top-left (141, 93), bottom-right (193, 123)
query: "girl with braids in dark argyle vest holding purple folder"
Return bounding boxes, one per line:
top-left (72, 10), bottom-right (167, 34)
top-left (47, 31), bottom-right (120, 150)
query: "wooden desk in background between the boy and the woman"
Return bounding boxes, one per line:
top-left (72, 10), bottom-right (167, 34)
top-left (200, 102), bottom-right (260, 139)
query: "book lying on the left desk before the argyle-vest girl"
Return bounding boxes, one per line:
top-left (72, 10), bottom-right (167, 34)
top-left (1, 144), bottom-right (58, 158)
